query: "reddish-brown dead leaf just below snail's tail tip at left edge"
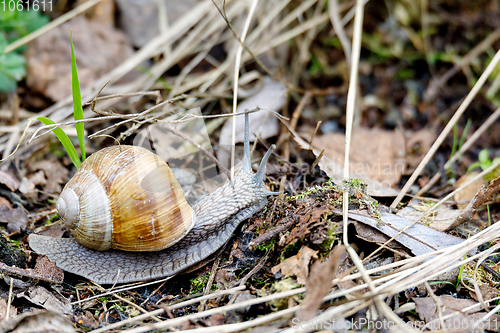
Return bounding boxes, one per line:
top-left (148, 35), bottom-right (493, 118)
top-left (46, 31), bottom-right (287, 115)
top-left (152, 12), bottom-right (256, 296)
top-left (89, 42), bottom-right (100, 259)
top-left (0, 256), bottom-right (64, 283)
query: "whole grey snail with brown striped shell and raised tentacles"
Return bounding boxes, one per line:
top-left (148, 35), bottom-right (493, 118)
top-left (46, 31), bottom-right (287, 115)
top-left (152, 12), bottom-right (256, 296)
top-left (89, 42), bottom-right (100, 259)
top-left (29, 114), bottom-right (276, 284)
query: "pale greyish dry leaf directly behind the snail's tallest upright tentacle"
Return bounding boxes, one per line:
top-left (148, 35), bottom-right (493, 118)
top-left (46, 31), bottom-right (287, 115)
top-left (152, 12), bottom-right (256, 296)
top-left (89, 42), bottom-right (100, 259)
top-left (217, 79), bottom-right (287, 168)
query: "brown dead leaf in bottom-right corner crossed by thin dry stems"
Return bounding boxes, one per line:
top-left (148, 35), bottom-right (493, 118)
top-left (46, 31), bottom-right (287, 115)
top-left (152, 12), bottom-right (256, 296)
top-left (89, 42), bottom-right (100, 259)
top-left (413, 295), bottom-right (500, 332)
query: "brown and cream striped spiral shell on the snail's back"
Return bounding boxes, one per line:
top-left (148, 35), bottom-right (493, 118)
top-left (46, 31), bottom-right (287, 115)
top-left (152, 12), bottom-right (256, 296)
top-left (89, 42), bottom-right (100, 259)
top-left (57, 146), bottom-right (196, 251)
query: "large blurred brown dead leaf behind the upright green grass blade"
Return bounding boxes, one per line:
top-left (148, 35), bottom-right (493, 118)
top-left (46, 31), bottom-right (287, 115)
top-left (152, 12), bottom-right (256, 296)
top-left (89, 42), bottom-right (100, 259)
top-left (25, 15), bottom-right (133, 101)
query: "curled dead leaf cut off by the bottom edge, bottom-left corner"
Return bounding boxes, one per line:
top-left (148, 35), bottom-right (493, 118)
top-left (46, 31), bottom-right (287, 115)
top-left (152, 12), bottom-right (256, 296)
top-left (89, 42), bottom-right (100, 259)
top-left (0, 310), bottom-right (75, 333)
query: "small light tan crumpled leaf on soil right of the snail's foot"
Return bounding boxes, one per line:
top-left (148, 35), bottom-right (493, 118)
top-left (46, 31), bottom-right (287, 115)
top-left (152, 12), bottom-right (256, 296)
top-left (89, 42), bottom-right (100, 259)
top-left (271, 246), bottom-right (318, 284)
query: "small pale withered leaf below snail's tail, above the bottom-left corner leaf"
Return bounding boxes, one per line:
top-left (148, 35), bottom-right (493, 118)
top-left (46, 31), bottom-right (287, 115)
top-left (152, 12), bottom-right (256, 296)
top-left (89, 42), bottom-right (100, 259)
top-left (17, 286), bottom-right (73, 315)
